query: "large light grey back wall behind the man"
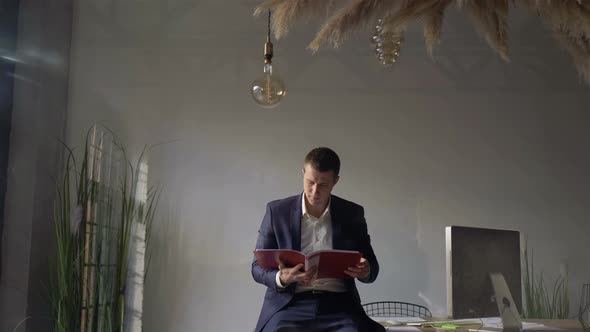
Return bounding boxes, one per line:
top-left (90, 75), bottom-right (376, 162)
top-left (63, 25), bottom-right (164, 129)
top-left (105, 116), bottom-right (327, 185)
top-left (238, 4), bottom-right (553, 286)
top-left (38, 0), bottom-right (590, 331)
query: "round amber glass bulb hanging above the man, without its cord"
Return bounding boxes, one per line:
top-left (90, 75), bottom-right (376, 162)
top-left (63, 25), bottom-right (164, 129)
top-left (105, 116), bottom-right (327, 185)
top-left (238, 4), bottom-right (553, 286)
top-left (250, 63), bottom-right (287, 108)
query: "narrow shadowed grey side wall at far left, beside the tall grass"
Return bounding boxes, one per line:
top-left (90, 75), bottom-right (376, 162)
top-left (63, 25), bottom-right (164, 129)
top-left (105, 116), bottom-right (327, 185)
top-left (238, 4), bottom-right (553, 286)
top-left (0, 0), bottom-right (72, 332)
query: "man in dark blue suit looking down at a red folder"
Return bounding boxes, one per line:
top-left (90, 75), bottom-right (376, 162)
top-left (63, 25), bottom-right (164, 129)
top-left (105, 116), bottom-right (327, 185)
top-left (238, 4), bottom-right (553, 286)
top-left (252, 148), bottom-right (385, 332)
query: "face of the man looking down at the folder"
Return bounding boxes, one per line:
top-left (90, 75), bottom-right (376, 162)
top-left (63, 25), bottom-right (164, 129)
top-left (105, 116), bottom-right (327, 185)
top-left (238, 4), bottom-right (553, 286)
top-left (303, 164), bottom-right (339, 209)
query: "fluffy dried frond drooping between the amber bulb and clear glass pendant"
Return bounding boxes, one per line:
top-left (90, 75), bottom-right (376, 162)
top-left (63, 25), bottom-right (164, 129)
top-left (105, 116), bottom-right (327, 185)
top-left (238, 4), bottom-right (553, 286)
top-left (308, 0), bottom-right (396, 52)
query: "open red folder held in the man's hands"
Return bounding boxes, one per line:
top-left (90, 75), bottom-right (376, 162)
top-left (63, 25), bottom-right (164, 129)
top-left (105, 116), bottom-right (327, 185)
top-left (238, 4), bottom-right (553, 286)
top-left (254, 249), bottom-right (362, 279)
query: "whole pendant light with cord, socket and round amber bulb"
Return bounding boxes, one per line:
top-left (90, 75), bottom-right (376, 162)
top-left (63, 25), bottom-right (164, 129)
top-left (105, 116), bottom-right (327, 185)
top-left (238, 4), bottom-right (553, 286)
top-left (250, 10), bottom-right (287, 108)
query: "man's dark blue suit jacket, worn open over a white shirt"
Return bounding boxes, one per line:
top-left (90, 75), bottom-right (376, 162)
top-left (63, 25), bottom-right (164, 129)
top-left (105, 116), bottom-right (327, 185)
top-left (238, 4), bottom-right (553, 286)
top-left (252, 194), bottom-right (379, 331)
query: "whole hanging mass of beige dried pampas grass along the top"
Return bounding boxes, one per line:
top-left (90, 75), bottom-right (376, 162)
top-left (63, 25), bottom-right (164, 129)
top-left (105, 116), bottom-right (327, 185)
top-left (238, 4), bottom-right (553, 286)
top-left (255, 0), bottom-right (590, 84)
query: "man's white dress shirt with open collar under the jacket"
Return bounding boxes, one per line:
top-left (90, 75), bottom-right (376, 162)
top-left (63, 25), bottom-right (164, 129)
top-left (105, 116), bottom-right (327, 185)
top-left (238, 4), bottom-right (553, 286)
top-left (275, 194), bottom-right (346, 293)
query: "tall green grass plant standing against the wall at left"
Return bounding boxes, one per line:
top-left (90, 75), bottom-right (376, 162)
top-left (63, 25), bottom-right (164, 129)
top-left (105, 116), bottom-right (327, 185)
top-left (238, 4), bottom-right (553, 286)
top-left (49, 127), bottom-right (159, 332)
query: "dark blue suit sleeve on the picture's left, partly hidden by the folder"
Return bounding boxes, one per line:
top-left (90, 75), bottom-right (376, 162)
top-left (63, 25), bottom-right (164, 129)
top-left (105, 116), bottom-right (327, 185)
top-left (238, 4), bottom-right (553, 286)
top-left (252, 204), bottom-right (284, 291)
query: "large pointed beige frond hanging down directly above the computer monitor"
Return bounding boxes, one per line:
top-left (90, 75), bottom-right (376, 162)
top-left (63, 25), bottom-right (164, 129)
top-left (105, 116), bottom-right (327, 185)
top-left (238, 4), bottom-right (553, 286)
top-left (462, 0), bottom-right (510, 61)
